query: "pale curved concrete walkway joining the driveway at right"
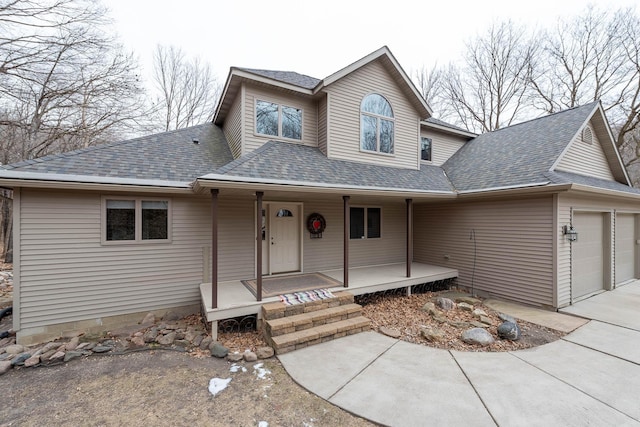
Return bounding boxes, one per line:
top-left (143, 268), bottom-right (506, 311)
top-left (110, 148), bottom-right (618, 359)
top-left (279, 282), bottom-right (640, 427)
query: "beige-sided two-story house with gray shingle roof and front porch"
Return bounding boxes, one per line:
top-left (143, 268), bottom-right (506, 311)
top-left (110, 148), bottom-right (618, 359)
top-left (0, 47), bottom-right (640, 343)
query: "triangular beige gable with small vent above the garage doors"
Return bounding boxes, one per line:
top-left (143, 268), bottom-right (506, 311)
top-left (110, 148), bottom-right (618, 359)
top-left (550, 102), bottom-right (631, 185)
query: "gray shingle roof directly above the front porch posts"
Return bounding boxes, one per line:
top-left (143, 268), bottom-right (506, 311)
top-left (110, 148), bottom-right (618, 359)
top-left (210, 141), bottom-right (453, 192)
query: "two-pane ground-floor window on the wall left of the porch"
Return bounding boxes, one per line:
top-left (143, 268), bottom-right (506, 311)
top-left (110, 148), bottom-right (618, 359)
top-left (102, 197), bottom-right (171, 243)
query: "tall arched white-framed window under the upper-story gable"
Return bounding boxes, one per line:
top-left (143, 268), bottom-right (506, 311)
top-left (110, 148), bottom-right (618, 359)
top-left (360, 93), bottom-right (394, 154)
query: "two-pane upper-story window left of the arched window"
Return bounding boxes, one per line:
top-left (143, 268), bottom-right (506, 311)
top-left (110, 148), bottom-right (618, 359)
top-left (256, 101), bottom-right (302, 140)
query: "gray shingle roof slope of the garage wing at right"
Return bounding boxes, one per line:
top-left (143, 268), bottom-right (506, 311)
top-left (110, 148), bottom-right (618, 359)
top-left (443, 102), bottom-right (598, 191)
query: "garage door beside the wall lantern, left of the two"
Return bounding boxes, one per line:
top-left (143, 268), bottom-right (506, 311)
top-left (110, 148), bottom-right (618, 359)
top-left (571, 212), bottom-right (604, 300)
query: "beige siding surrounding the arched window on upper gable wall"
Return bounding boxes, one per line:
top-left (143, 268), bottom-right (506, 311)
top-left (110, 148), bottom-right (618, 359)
top-left (326, 61), bottom-right (420, 169)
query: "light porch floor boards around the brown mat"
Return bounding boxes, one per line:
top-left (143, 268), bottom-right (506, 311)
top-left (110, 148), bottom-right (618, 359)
top-left (200, 262), bottom-right (458, 322)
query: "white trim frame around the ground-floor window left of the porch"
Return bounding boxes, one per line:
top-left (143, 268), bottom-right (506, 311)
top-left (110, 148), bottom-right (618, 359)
top-left (100, 195), bottom-right (173, 246)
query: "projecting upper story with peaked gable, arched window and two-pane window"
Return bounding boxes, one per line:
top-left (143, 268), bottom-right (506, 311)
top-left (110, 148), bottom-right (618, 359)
top-left (214, 46), bottom-right (432, 169)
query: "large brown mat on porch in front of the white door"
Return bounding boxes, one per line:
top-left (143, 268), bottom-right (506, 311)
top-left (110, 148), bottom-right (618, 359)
top-left (242, 273), bottom-right (342, 297)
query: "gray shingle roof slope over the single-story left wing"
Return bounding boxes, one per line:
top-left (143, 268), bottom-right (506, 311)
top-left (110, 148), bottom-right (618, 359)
top-left (5, 123), bottom-right (233, 182)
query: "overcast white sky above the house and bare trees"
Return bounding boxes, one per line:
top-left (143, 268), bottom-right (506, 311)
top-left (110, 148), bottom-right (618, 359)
top-left (105, 0), bottom-right (638, 83)
